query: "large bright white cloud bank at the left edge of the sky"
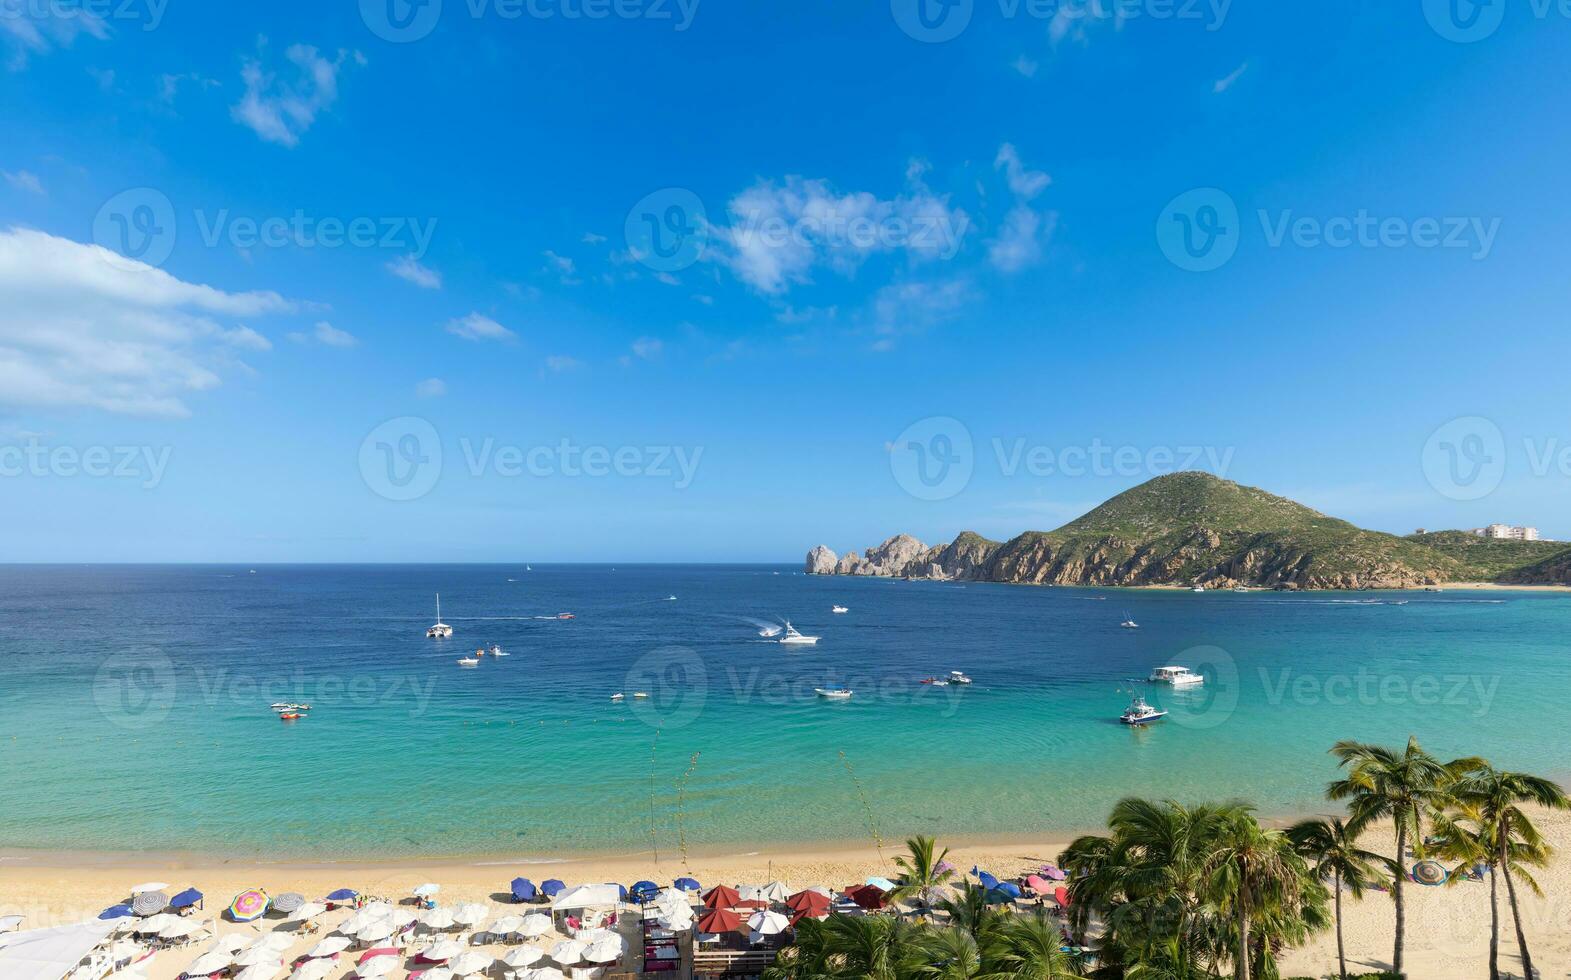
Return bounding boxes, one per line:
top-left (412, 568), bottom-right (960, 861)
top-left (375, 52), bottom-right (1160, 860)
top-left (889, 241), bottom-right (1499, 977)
top-left (0, 228), bottom-right (295, 418)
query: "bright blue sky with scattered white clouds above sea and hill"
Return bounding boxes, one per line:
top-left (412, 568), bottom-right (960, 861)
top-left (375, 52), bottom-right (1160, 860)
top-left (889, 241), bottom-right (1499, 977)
top-left (0, 0), bottom-right (1571, 562)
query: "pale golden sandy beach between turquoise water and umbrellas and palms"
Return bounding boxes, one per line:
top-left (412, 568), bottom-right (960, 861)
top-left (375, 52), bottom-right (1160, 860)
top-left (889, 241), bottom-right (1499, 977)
top-left (0, 814), bottom-right (1571, 980)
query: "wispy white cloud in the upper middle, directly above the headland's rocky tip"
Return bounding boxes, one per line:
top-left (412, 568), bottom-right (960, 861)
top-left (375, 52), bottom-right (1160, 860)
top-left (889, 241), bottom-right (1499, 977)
top-left (710, 166), bottom-right (969, 295)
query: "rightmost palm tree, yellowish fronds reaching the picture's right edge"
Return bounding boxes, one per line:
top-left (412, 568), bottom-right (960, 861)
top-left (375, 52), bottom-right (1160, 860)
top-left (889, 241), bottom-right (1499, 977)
top-left (1448, 763), bottom-right (1571, 980)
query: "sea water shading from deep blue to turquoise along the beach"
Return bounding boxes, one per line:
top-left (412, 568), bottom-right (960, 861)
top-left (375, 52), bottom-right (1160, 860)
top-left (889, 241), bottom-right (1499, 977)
top-left (0, 565), bottom-right (1571, 858)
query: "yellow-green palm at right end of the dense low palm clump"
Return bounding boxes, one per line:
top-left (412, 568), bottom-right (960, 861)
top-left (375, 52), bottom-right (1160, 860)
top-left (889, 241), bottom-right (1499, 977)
top-left (1203, 806), bottom-right (1309, 980)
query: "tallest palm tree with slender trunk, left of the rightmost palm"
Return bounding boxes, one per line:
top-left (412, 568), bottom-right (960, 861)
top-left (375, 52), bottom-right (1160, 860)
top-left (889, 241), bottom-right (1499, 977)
top-left (1326, 738), bottom-right (1483, 974)
